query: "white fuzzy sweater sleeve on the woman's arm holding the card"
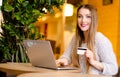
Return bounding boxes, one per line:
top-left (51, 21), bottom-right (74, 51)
top-left (96, 33), bottom-right (118, 75)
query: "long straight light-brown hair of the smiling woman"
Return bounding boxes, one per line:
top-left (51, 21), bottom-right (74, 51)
top-left (72, 4), bottom-right (98, 73)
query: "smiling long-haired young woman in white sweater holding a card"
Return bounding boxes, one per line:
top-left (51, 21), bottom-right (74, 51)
top-left (56, 4), bottom-right (118, 76)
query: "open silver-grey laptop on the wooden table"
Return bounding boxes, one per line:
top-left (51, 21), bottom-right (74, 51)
top-left (23, 40), bottom-right (77, 70)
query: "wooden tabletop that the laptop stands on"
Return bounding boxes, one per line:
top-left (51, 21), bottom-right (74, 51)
top-left (0, 63), bottom-right (80, 74)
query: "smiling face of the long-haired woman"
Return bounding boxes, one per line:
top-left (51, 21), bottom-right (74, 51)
top-left (77, 8), bottom-right (91, 32)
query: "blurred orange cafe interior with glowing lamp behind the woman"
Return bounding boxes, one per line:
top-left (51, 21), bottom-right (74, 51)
top-left (35, 0), bottom-right (120, 65)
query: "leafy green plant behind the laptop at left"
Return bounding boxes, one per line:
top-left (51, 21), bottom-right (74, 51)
top-left (0, 0), bottom-right (64, 62)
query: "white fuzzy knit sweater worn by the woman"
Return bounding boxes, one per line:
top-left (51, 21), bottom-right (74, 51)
top-left (61, 32), bottom-right (118, 76)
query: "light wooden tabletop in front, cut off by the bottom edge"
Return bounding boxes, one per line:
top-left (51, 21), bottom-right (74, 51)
top-left (17, 72), bottom-right (110, 77)
